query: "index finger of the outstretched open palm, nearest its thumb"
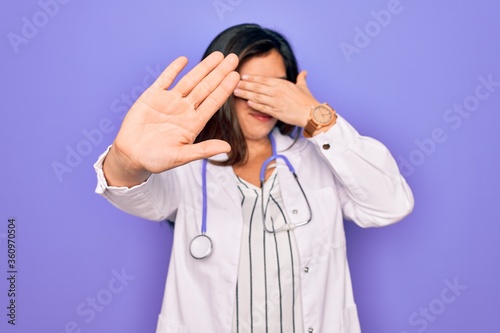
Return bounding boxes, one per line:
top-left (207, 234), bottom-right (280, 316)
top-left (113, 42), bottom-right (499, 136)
top-left (197, 72), bottom-right (240, 119)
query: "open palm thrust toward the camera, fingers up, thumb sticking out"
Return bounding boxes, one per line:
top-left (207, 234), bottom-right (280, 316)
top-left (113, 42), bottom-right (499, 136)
top-left (103, 52), bottom-right (239, 187)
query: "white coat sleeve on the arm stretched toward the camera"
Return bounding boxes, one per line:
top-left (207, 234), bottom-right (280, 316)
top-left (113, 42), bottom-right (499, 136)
top-left (94, 146), bottom-right (181, 221)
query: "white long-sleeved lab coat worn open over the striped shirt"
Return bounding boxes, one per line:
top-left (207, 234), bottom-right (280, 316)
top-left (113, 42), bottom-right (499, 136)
top-left (95, 116), bottom-right (413, 333)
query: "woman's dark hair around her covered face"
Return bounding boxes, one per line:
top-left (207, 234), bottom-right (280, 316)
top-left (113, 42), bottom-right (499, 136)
top-left (195, 24), bottom-right (299, 165)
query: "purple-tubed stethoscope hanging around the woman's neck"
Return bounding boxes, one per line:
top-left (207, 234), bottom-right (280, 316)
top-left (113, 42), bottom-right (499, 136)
top-left (189, 134), bottom-right (312, 259)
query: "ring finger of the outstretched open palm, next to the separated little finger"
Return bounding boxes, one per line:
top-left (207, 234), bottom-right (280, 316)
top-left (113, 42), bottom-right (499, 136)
top-left (172, 52), bottom-right (224, 96)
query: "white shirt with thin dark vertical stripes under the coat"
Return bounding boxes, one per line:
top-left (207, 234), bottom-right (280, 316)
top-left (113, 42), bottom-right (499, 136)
top-left (233, 169), bottom-right (303, 333)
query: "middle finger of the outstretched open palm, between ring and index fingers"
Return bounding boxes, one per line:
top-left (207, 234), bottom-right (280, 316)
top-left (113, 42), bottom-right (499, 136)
top-left (188, 54), bottom-right (238, 109)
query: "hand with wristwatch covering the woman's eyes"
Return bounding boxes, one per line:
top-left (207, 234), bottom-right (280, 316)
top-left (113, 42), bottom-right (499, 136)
top-left (234, 71), bottom-right (320, 127)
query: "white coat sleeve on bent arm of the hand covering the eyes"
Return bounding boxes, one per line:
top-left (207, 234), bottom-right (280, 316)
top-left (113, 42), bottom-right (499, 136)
top-left (309, 116), bottom-right (414, 227)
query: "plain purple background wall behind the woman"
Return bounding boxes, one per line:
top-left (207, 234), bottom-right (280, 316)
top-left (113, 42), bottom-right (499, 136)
top-left (0, 0), bottom-right (500, 333)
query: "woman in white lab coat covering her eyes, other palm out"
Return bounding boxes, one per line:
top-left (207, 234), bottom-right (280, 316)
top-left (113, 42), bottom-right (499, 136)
top-left (95, 24), bottom-right (413, 332)
